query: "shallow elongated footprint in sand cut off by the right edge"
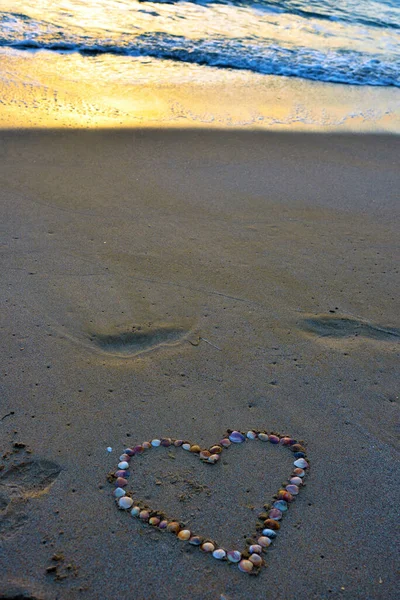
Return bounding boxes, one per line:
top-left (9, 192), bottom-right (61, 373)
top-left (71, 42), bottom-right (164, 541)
top-left (302, 315), bottom-right (400, 342)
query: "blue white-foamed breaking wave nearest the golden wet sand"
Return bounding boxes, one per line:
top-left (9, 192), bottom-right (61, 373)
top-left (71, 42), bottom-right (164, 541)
top-left (0, 34), bottom-right (400, 87)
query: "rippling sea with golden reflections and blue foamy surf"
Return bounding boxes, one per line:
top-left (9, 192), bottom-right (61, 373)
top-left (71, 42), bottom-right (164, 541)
top-left (0, 0), bottom-right (400, 87)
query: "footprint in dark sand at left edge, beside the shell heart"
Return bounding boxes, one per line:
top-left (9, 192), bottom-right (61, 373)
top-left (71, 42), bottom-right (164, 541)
top-left (0, 460), bottom-right (61, 535)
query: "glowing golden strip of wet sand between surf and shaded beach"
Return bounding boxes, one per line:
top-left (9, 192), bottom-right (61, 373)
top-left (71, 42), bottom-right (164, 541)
top-left (0, 49), bottom-right (400, 133)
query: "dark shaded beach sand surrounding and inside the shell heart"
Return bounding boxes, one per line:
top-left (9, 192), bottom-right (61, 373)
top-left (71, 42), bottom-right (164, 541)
top-left (0, 130), bottom-right (400, 600)
